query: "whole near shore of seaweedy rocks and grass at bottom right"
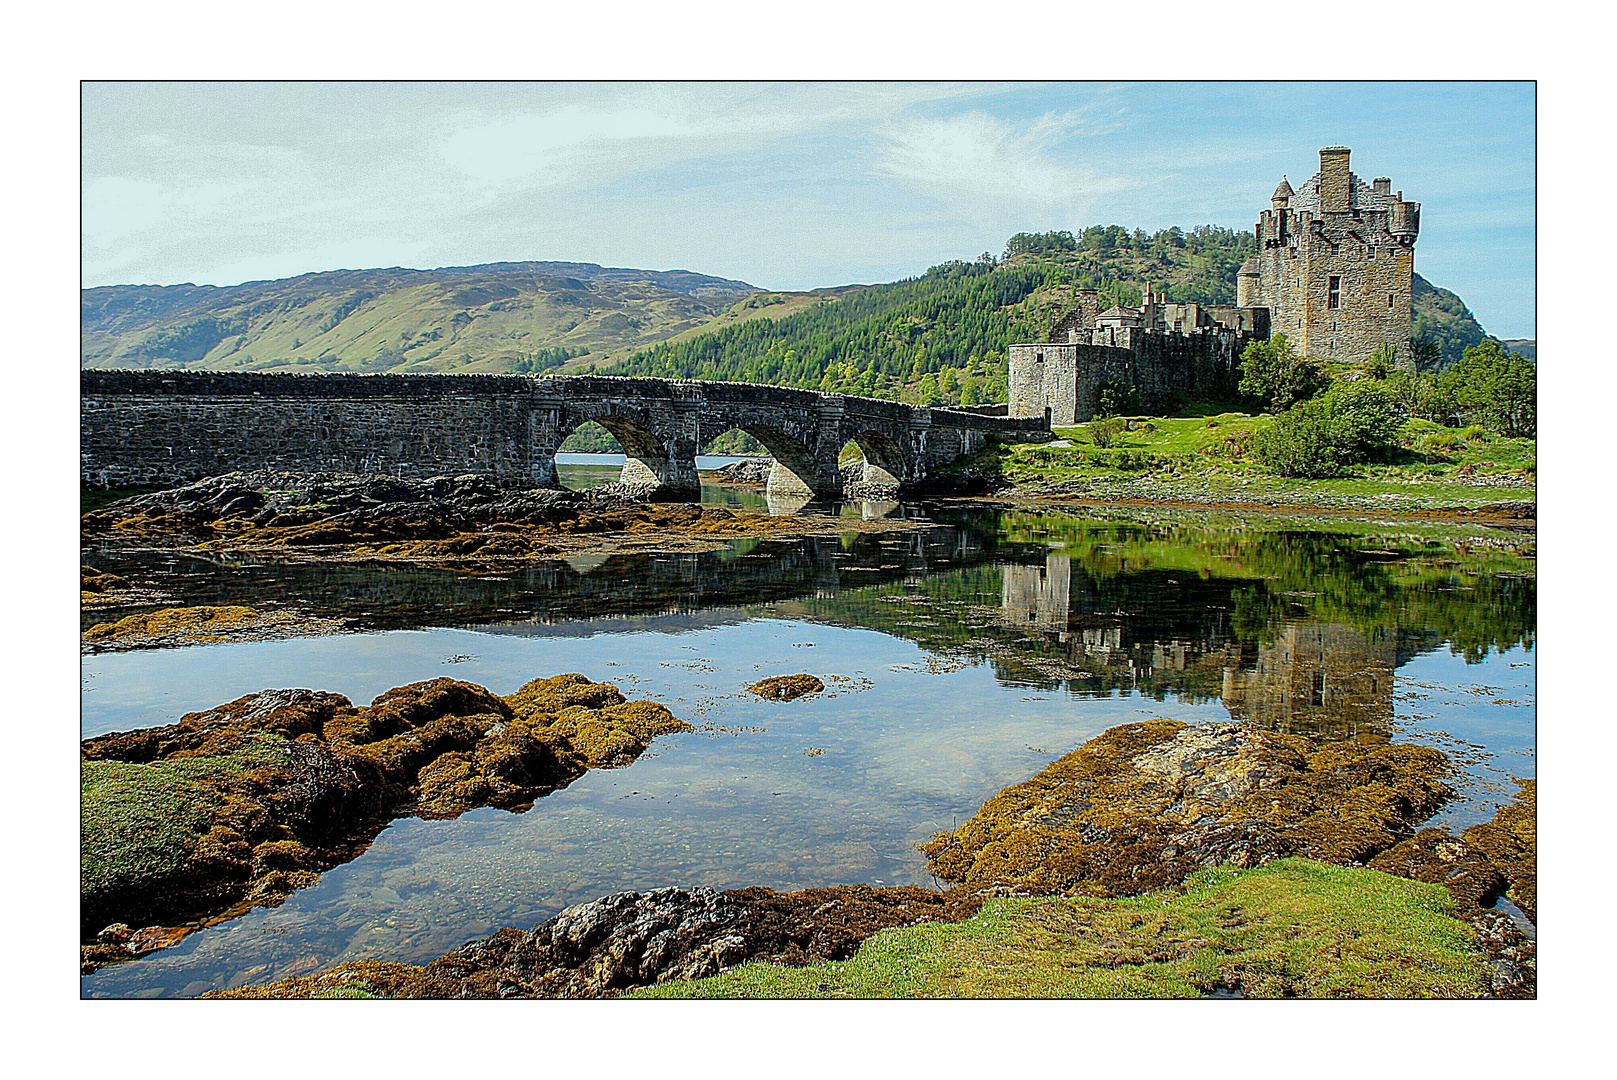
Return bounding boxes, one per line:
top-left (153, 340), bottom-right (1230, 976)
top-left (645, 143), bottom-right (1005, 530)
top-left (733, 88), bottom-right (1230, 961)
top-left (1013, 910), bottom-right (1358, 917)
top-left (222, 721), bottom-right (1536, 998)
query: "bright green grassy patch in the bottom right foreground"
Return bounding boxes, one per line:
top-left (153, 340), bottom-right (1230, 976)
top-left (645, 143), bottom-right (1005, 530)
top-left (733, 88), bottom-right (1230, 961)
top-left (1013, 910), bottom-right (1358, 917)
top-left (635, 859), bottom-right (1488, 998)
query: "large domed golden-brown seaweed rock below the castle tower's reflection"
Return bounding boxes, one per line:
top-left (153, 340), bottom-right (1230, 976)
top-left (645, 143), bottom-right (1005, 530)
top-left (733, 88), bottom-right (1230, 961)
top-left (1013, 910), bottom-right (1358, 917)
top-left (922, 719), bottom-right (1450, 896)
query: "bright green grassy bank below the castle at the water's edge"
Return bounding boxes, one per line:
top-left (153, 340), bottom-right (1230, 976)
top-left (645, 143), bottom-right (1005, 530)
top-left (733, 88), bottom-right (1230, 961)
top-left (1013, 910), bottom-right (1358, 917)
top-left (977, 412), bottom-right (1538, 511)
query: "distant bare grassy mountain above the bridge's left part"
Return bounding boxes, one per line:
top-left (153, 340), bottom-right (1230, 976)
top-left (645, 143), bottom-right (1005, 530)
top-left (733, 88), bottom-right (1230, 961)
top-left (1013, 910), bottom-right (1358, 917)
top-left (81, 262), bottom-right (760, 372)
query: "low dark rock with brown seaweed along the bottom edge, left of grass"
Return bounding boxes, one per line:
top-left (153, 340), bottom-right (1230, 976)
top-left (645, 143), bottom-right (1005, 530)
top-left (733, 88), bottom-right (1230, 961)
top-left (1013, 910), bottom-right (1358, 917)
top-left (213, 886), bottom-right (946, 998)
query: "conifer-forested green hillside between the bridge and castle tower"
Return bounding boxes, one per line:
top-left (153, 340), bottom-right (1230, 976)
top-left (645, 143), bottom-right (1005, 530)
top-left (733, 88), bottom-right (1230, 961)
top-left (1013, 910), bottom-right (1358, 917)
top-left (611, 225), bottom-right (1252, 404)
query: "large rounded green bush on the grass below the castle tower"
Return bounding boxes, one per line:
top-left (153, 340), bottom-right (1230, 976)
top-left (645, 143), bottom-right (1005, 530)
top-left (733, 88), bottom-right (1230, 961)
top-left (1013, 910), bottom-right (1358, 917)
top-left (1253, 382), bottom-right (1404, 479)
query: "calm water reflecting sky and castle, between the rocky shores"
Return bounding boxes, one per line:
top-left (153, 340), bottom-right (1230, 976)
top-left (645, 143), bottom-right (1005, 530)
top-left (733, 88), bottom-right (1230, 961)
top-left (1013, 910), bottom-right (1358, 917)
top-left (82, 494), bottom-right (1536, 996)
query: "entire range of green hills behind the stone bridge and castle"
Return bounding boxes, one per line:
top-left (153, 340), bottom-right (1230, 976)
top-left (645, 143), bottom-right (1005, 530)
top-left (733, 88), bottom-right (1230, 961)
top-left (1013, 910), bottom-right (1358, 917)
top-left (81, 225), bottom-right (1486, 396)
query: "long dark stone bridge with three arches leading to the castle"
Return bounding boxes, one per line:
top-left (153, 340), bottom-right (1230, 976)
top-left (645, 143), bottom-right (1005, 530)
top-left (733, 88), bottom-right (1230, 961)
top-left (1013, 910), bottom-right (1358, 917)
top-left (79, 370), bottom-right (1049, 498)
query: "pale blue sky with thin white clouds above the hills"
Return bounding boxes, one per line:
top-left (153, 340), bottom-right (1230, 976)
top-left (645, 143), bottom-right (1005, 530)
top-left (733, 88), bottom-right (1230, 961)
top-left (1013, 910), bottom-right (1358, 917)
top-left (82, 82), bottom-right (1536, 338)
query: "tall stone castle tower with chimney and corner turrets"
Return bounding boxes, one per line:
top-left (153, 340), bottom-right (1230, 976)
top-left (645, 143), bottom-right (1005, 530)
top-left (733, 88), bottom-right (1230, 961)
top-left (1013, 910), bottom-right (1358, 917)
top-left (1235, 146), bottom-right (1420, 367)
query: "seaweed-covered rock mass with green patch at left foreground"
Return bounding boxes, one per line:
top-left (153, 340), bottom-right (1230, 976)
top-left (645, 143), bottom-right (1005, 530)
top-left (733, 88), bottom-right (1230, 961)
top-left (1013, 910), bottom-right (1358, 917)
top-left (81, 674), bottom-right (686, 963)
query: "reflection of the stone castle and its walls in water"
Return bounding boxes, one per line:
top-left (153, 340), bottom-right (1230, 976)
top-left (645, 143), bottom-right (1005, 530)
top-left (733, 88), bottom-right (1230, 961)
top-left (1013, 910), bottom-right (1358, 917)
top-left (1001, 551), bottom-right (1399, 736)
